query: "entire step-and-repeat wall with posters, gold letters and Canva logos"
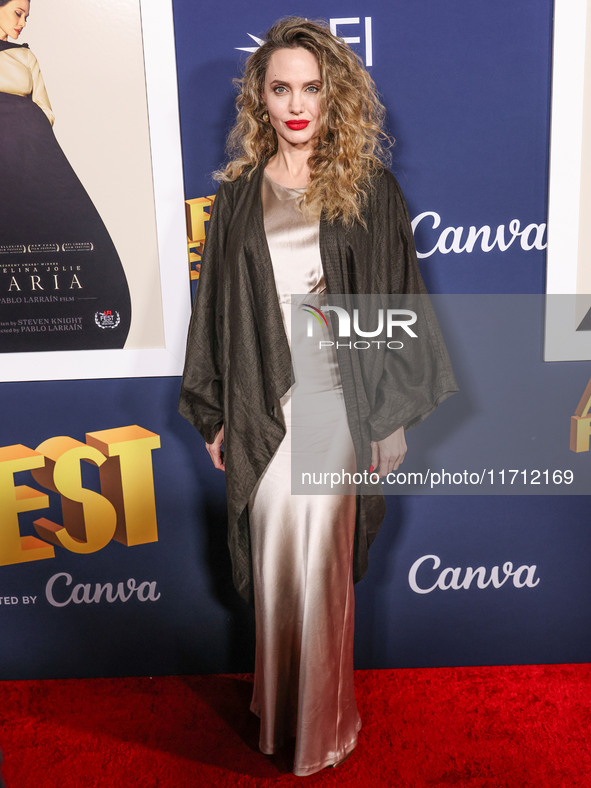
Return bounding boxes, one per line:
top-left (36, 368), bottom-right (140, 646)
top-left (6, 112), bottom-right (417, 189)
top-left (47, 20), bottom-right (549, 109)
top-left (0, 0), bottom-right (591, 679)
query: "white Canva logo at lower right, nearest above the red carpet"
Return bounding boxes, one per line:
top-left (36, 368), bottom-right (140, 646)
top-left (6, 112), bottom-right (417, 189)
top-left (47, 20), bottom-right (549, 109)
top-left (408, 555), bottom-right (540, 594)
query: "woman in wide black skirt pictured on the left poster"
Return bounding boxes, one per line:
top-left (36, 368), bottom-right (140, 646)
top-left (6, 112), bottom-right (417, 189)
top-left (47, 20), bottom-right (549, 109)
top-left (0, 0), bottom-right (131, 352)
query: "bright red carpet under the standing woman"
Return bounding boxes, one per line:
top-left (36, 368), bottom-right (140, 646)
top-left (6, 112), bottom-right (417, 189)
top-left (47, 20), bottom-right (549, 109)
top-left (0, 665), bottom-right (591, 788)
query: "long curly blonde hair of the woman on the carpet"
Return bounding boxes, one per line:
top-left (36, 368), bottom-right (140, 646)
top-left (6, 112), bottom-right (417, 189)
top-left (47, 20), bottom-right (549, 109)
top-left (214, 16), bottom-right (394, 225)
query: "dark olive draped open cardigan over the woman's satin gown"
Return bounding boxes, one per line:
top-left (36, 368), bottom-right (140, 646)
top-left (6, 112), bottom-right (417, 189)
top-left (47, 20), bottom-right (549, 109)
top-left (179, 162), bottom-right (457, 602)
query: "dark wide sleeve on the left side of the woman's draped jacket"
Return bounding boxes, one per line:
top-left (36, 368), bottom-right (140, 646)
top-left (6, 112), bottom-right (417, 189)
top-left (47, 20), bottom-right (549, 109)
top-left (179, 183), bottom-right (231, 443)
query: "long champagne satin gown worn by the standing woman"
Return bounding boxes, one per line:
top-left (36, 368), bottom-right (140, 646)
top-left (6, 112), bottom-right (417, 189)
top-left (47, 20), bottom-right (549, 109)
top-left (249, 173), bottom-right (361, 776)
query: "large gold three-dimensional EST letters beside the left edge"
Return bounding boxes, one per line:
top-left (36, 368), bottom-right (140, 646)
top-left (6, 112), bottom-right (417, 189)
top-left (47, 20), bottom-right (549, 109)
top-left (0, 425), bottom-right (160, 566)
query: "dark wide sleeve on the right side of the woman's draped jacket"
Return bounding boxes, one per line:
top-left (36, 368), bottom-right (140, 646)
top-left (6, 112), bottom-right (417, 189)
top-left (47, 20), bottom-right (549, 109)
top-left (369, 172), bottom-right (458, 441)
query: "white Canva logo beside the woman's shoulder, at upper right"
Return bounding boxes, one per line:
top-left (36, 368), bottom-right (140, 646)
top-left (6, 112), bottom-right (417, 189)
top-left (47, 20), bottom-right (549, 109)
top-left (412, 211), bottom-right (547, 257)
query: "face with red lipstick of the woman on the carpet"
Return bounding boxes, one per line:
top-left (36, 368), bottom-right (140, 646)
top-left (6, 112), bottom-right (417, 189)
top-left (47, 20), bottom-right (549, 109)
top-left (263, 47), bottom-right (322, 151)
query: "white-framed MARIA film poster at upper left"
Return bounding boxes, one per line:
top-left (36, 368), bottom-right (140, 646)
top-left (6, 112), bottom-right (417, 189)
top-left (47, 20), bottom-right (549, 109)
top-left (0, 0), bottom-right (188, 379)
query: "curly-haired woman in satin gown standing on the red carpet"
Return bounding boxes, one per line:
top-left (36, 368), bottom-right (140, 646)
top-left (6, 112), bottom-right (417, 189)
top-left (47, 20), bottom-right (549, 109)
top-left (180, 17), bottom-right (456, 775)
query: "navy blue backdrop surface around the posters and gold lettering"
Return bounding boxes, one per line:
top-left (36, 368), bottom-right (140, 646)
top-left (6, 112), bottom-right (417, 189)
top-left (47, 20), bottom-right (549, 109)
top-left (0, 0), bottom-right (591, 678)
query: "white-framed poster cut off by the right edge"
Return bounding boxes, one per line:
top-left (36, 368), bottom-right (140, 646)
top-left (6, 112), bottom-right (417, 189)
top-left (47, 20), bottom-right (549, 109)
top-left (545, 0), bottom-right (591, 361)
